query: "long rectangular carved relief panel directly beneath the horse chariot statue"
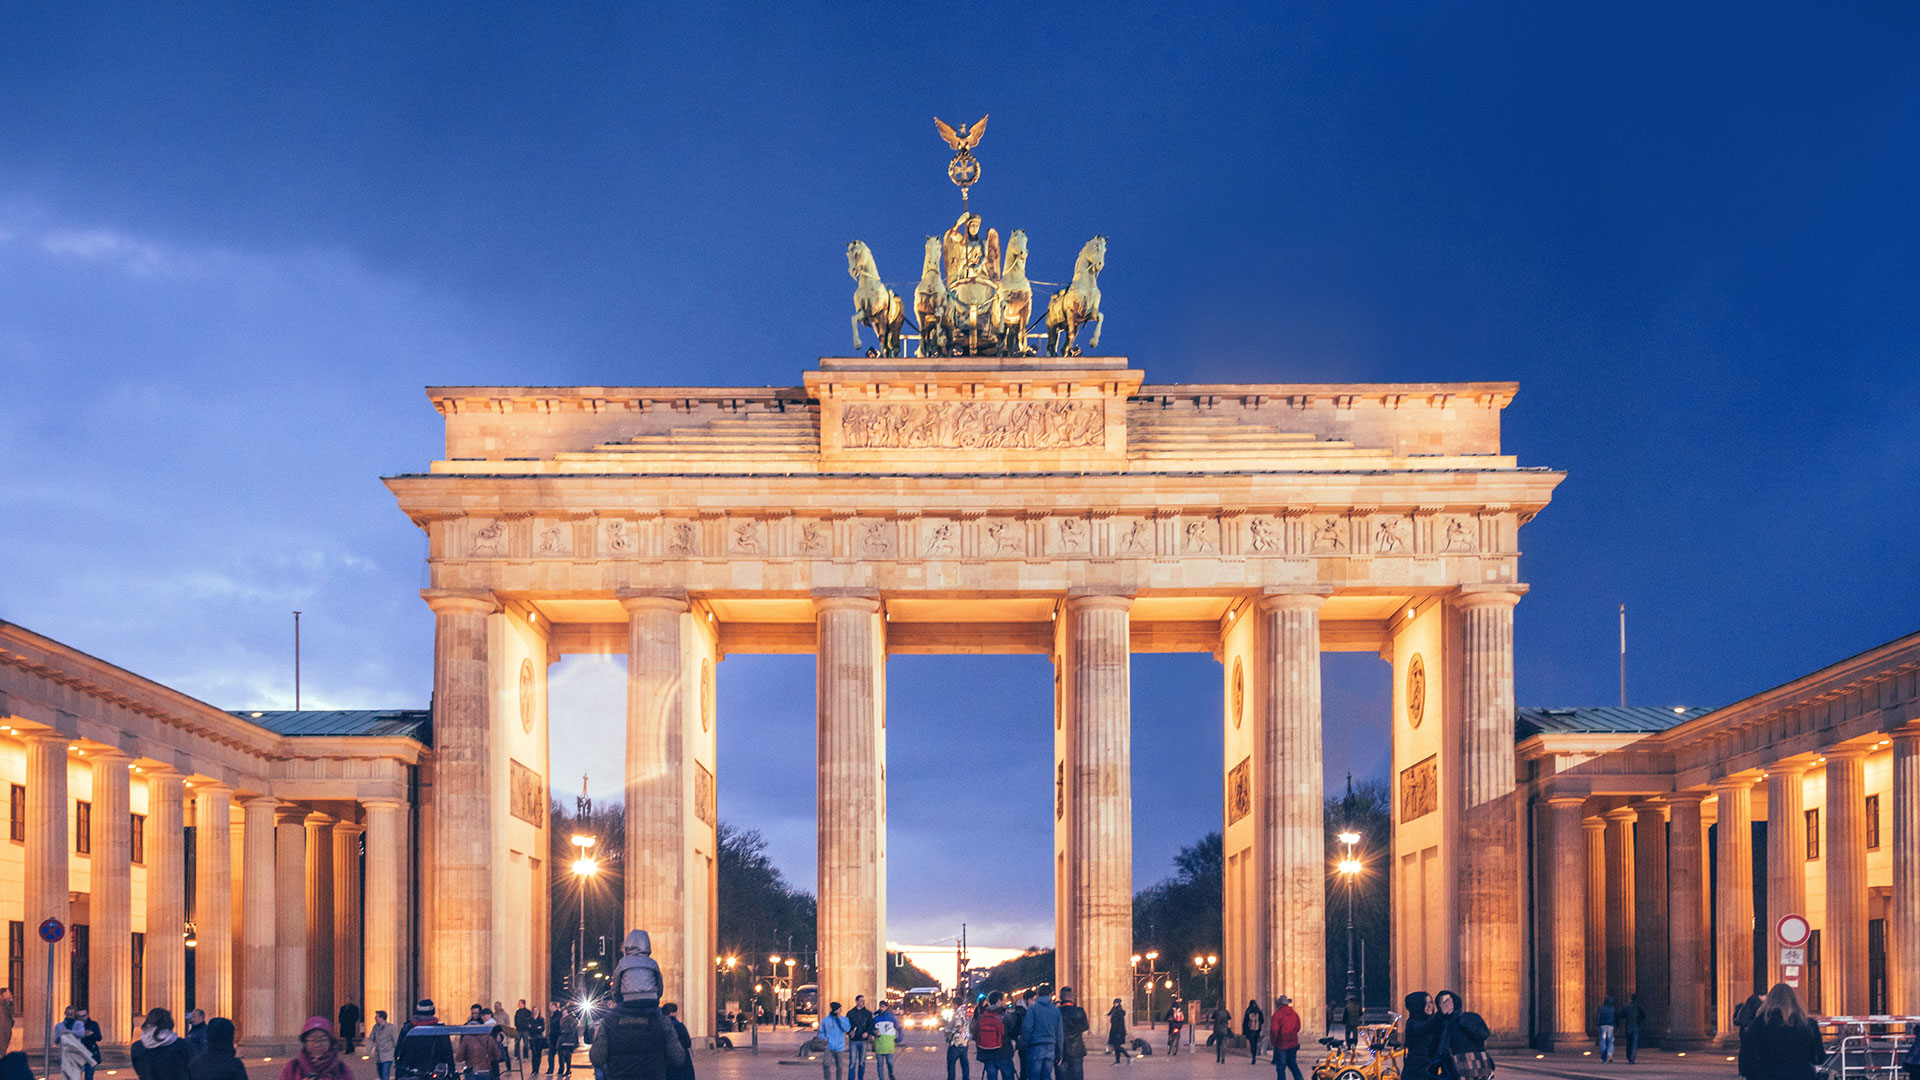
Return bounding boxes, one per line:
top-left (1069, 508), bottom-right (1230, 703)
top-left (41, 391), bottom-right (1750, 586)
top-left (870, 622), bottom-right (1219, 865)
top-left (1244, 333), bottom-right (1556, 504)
top-left (841, 402), bottom-right (1106, 450)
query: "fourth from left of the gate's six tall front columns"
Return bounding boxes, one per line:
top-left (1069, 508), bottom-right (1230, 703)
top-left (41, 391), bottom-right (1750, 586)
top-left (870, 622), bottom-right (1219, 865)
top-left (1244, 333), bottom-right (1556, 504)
top-left (1056, 594), bottom-right (1133, 1001)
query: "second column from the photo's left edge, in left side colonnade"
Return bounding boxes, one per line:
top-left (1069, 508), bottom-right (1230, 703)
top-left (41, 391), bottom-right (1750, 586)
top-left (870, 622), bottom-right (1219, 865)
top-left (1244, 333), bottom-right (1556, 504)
top-left (86, 749), bottom-right (132, 1034)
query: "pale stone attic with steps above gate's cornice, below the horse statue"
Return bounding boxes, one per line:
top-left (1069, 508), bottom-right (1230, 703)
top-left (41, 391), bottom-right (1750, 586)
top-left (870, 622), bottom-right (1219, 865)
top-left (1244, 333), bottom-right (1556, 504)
top-left (428, 357), bottom-right (1517, 475)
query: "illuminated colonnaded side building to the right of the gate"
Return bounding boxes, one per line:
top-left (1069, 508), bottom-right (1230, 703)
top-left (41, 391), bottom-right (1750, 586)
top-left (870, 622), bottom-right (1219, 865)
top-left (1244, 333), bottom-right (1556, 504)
top-left (1517, 634), bottom-right (1920, 1049)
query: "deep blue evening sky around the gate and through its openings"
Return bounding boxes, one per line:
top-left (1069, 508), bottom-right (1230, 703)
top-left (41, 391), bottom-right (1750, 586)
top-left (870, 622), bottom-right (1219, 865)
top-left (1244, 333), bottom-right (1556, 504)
top-left (0, 2), bottom-right (1920, 945)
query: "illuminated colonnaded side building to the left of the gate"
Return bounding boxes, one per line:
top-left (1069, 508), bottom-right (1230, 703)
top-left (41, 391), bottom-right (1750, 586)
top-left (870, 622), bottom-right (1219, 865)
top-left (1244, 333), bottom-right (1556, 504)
top-left (0, 621), bottom-right (428, 1051)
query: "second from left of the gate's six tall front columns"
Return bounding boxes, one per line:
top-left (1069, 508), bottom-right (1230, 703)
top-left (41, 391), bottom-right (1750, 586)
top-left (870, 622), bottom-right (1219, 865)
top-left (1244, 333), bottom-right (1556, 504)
top-left (620, 594), bottom-right (705, 997)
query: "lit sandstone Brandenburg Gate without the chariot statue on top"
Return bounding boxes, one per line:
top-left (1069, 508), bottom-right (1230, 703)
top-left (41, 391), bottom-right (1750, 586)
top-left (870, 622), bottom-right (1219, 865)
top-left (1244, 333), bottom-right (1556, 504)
top-left (388, 351), bottom-right (1563, 1038)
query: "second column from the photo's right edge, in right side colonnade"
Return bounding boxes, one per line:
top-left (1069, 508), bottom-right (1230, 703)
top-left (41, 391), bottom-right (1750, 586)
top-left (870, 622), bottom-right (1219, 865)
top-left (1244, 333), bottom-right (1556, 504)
top-left (1820, 746), bottom-right (1868, 1017)
